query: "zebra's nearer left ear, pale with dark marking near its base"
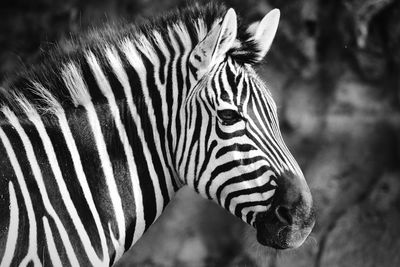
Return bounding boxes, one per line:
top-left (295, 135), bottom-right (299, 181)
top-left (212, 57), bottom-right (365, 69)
top-left (189, 8), bottom-right (237, 76)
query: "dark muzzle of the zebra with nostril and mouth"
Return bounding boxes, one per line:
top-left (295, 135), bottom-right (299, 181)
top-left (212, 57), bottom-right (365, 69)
top-left (255, 174), bottom-right (315, 249)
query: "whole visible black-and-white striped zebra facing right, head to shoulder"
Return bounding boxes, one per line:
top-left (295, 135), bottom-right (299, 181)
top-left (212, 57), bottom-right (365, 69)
top-left (0, 3), bottom-right (315, 267)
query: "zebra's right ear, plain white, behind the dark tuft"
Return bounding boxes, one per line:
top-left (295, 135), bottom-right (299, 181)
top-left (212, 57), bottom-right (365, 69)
top-left (247, 9), bottom-right (281, 60)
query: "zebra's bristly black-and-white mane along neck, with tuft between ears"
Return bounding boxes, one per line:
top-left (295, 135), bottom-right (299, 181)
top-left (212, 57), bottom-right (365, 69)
top-left (0, 2), bottom-right (258, 114)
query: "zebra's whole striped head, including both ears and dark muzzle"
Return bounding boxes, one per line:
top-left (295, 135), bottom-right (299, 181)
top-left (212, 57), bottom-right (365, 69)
top-left (178, 9), bottom-right (315, 249)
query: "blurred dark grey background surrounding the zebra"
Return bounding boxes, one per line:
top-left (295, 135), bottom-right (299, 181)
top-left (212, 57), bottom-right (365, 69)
top-left (0, 0), bottom-right (400, 267)
